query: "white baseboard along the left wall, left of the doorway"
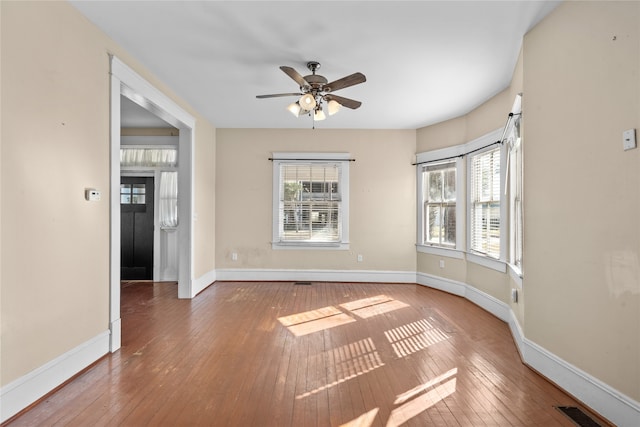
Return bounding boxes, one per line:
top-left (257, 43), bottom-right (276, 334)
top-left (0, 331), bottom-right (110, 422)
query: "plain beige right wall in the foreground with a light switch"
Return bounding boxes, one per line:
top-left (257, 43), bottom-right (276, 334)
top-left (523, 2), bottom-right (640, 401)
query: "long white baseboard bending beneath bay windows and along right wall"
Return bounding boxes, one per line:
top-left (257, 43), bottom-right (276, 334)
top-left (416, 273), bottom-right (640, 427)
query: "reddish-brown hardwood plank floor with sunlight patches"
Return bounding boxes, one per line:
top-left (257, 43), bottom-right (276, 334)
top-left (10, 282), bottom-right (602, 427)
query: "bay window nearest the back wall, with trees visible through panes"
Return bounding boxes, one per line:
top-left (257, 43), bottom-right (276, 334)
top-left (422, 162), bottom-right (456, 248)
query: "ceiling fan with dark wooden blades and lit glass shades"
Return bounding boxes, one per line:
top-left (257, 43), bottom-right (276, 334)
top-left (256, 61), bottom-right (367, 120)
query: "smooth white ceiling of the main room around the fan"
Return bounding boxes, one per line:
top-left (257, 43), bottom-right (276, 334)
top-left (71, 1), bottom-right (559, 129)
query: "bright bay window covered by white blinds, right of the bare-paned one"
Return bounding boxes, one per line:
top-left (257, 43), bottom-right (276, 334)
top-left (469, 146), bottom-right (502, 259)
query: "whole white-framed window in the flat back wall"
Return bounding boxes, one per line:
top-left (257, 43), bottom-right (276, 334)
top-left (273, 153), bottom-right (349, 249)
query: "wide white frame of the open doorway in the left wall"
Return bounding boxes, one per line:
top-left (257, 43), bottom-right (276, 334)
top-left (109, 55), bottom-right (195, 352)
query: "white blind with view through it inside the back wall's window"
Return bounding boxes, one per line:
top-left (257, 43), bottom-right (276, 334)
top-left (277, 161), bottom-right (343, 243)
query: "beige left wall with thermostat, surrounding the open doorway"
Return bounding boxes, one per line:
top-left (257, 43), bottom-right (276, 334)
top-left (0, 1), bottom-right (215, 385)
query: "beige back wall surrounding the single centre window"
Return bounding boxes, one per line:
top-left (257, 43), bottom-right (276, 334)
top-left (216, 129), bottom-right (416, 271)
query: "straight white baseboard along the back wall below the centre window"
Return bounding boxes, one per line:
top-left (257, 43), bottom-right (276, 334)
top-left (216, 269), bottom-right (416, 283)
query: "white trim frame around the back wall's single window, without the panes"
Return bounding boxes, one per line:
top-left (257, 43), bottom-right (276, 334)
top-left (271, 152), bottom-right (351, 250)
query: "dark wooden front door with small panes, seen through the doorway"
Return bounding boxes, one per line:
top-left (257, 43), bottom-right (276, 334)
top-left (120, 177), bottom-right (153, 280)
